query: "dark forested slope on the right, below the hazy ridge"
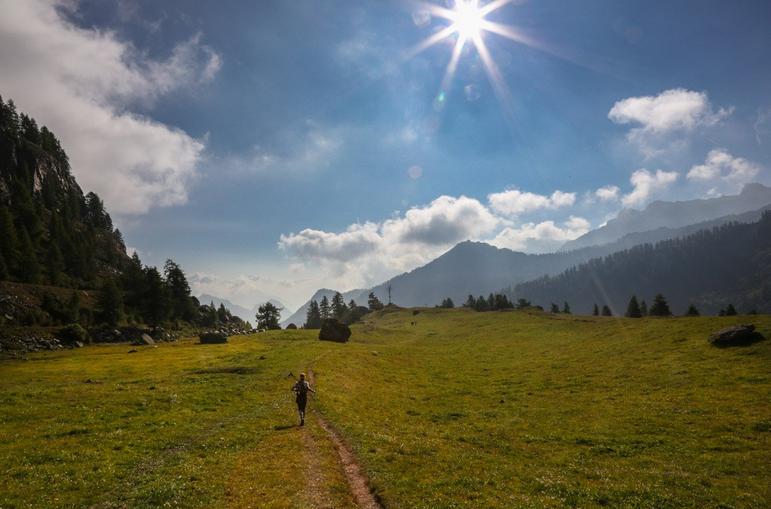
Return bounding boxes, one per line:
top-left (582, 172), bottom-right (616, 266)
top-left (514, 211), bottom-right (771, 315)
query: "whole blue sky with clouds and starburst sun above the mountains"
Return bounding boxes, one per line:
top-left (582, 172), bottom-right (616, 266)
top-left (0, 0), bottom-right (771, 307)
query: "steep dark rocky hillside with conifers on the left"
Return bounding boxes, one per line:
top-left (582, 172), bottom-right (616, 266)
top-left (0, 98), bottom-right (238, 327)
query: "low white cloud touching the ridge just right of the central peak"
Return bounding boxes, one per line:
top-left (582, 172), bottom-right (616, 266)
top-left (490, 216), bottom-right (591, 253)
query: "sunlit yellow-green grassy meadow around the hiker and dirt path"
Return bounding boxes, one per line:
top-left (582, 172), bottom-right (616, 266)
top-left (0, 309), bottom-right (771, 509)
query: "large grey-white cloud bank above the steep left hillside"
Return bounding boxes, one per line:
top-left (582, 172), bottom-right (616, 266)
top-left (0, 0), bottom-right (221, 214)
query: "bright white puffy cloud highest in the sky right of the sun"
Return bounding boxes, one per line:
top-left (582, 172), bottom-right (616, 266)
top-left (608, 88), bottom-right (730, 133)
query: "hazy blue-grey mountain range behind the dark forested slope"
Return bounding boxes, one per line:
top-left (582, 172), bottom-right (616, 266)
top-left (282, 184), bottom-right (771, 326)
